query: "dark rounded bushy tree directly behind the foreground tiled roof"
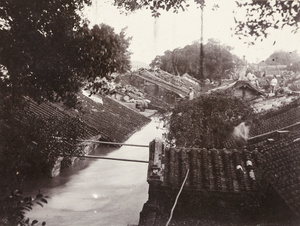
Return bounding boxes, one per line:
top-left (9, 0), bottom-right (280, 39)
top-left (166, 94), bottom-right (253, 148)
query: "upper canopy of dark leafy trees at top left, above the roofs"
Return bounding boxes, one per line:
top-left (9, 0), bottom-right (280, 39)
top-left (0, 0), bottom-right (129, 105)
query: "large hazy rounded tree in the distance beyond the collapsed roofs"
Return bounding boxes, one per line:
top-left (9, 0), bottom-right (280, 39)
top-left (150, 39), bottom-right (239, 80)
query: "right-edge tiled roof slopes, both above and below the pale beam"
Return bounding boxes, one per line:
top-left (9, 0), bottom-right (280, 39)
top-left (237, 99), bottom-right (300, 216)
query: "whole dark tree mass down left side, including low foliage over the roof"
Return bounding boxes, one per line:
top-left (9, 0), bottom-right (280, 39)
top-left (0, 0), bottom-right (130, 225)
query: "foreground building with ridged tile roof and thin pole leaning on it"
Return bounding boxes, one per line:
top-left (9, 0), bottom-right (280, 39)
top-left (139, 139), bottom-right (265, 226)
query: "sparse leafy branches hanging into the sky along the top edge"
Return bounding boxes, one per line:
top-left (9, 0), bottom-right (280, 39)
top-left (114, 0), bottom-right (300, 38)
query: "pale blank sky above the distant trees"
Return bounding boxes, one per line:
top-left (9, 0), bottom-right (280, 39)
top-left (85, 0), bottom-right (300, 64)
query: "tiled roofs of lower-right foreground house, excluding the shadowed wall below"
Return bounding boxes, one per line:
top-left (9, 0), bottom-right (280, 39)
top-left (142, 97), bottom-right (300, 225)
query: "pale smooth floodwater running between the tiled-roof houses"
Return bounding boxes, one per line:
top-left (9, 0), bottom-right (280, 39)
top-left (27, 120), bottom-right (164, 226)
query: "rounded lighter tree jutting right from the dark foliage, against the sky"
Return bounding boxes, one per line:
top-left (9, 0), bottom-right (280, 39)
top-left (75, 24), bottom-right (131, 94)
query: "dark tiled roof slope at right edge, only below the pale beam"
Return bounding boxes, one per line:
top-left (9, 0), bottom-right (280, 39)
top-left (248, 122), bottom-right (300, 216)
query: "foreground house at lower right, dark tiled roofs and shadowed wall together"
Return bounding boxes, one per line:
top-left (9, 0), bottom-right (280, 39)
top-left (139, 99), bottom-right (300, 226)
